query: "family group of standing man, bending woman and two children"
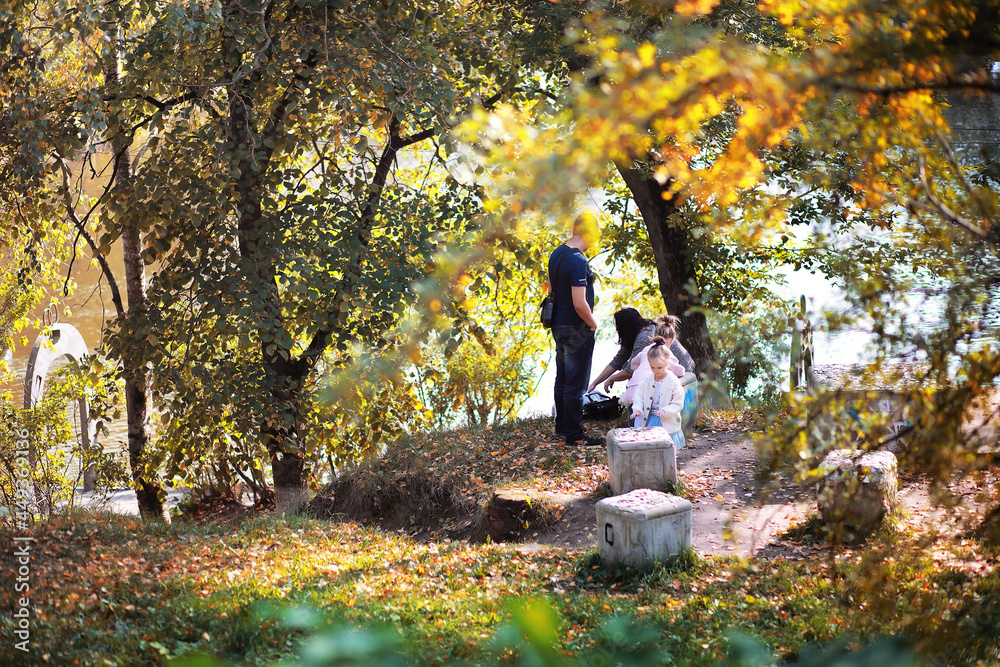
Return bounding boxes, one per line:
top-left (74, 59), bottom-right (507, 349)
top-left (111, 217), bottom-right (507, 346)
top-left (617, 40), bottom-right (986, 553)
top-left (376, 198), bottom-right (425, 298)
top-left (548, 218), bottom-right (694, 447)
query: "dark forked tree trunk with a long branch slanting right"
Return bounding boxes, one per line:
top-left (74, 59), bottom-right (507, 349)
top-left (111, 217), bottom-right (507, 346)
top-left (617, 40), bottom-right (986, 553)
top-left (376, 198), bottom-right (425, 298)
top-left (222, 14), bottom-right (437, 513)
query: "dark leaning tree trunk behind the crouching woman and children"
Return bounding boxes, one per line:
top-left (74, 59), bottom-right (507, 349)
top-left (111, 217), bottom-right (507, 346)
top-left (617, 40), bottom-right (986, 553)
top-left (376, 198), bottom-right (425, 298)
top-left (617, 164), bottom-right (719, 380)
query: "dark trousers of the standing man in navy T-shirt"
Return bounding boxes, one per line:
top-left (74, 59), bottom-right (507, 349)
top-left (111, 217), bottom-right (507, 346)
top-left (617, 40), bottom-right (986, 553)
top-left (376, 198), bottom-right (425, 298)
top-left (552, 324), bottom-right (594, 442)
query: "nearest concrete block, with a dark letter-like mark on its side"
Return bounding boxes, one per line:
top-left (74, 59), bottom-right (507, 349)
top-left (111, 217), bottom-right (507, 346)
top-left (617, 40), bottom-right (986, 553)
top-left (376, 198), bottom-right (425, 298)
top-left (597, 489), bottom-right (691, 567)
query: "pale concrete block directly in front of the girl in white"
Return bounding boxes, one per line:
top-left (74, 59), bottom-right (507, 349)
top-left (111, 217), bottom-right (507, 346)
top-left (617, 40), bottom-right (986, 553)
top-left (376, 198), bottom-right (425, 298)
top-left (607, 426), bottom-right (677, 495)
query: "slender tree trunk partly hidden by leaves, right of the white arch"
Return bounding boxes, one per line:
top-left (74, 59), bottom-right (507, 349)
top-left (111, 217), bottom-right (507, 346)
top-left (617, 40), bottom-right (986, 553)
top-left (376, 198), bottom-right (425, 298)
top-left (104, 7), bottom-right (170, 521)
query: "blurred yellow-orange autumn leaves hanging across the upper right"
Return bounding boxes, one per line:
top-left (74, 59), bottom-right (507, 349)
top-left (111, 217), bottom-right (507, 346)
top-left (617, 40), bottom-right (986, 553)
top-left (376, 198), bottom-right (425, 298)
top-left (459, 0), bottom-right (970, 248)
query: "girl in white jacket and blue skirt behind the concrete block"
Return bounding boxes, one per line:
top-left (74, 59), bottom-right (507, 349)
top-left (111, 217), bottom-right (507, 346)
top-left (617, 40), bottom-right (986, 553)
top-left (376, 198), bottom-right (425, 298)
top-left (632, 336), bottom-right (684, 449)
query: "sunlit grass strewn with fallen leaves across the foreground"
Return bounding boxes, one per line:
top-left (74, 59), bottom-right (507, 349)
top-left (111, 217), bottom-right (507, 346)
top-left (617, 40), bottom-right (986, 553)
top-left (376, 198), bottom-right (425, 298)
top-left (2, 514), bottom-right (996, 665)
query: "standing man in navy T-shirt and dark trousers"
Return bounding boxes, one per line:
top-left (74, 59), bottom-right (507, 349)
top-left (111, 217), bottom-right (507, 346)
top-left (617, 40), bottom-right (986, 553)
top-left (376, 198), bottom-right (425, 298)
top-left (549, 214), bottom-right (604, 445)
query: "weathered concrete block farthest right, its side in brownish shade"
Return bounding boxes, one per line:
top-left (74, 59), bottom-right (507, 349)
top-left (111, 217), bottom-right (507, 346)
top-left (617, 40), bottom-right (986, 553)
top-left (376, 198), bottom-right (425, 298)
top-left (816, 449), bottom-right (899, 529)
